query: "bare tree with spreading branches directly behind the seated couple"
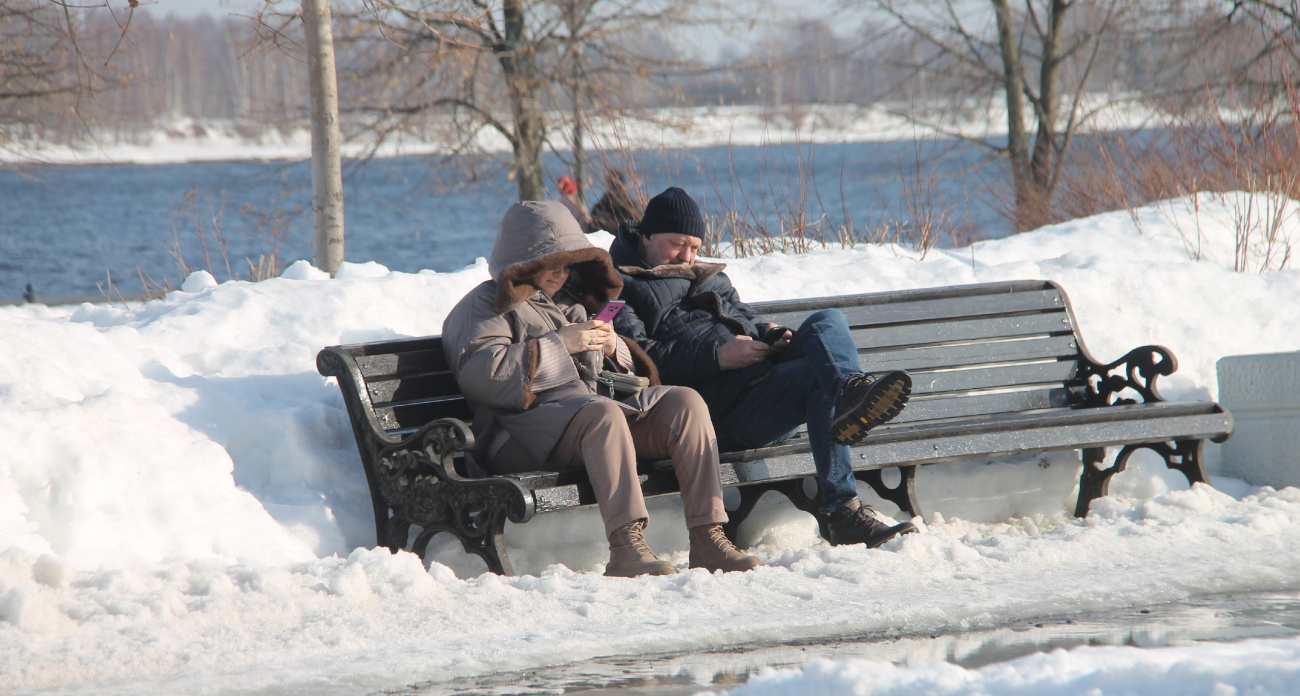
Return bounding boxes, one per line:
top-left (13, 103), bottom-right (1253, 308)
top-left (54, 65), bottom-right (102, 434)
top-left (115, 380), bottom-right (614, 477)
top-left (253, 0), bottom-right (743, 200)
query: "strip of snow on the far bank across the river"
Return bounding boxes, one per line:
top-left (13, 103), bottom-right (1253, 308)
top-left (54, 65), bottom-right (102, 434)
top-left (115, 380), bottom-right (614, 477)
top-left (0, 96), bottom-right (1166, 164)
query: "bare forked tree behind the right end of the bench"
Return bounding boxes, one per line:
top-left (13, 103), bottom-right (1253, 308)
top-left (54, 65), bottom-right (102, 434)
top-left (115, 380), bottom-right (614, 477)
top-left (867, 0), bottom-right (1143, 230)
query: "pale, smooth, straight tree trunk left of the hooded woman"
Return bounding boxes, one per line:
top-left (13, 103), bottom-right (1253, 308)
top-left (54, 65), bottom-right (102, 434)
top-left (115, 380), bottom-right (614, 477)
top-left (303, 0), bottom-right (343, 276)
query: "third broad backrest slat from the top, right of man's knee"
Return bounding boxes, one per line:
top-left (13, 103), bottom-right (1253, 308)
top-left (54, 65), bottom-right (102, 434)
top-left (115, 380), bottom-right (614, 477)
top-left (858, 336), bottom-right (1079, 372)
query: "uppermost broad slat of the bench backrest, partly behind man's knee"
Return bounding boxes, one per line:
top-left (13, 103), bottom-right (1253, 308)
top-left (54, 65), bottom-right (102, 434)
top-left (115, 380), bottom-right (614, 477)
top-left (764, 290), bottom-right (1065, 327)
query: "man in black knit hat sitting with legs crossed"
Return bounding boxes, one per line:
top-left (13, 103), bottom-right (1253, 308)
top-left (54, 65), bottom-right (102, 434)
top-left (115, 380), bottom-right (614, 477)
top-left (610, 187), bottom-right (917, 548)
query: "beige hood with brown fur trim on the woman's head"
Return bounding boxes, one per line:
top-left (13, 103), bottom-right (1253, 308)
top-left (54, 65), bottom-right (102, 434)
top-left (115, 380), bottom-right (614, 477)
top-left (488, 200), bottom-right (623, 315)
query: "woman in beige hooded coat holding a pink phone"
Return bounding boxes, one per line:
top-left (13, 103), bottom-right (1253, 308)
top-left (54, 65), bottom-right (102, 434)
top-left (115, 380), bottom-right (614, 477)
top-left (442, 202), bottom-right (762, 576)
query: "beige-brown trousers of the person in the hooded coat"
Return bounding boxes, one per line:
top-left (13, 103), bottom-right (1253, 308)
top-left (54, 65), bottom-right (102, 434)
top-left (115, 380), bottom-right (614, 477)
top-left (489, 386), bottom-right (727, 536)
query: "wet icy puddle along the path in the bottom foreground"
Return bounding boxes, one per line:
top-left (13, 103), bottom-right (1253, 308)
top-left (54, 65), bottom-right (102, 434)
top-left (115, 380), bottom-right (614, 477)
top-left (402, 592), bottom-right (1300, 696)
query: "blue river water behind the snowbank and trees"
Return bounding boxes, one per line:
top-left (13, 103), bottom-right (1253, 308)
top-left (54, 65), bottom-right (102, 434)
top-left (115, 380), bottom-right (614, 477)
top-left (0, 141), bottom-right (1009, 302)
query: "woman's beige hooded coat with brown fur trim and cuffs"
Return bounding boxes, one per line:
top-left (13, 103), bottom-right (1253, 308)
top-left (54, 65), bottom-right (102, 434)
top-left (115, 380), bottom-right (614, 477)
top-left (442, 200), bottom-right (666, 468)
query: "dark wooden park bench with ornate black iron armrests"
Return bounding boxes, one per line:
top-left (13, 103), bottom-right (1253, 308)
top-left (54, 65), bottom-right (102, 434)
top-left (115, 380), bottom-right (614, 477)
top-left (316, 281), bottom-right (1232, 574)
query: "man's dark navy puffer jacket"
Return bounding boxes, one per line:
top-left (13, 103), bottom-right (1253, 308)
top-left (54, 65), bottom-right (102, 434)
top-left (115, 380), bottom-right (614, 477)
top-left (610, 222), bottom-right (772, 419)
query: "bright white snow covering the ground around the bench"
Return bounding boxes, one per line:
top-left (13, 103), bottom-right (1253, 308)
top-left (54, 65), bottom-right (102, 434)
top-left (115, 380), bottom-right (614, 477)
top-left (0, 194), bottom-right (1300, 695)
